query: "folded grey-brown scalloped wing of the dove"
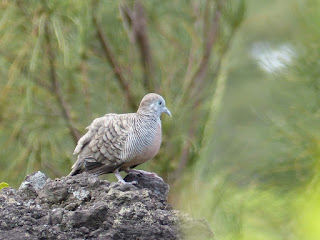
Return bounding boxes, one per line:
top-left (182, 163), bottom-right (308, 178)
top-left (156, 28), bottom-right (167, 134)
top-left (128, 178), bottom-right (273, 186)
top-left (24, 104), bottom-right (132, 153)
top-left (74, 114), bottom-right (133, 174)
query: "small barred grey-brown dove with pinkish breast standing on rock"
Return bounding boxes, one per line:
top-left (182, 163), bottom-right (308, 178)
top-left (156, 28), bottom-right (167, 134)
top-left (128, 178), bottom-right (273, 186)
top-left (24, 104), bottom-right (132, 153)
top-left (68, 93), bottom-right (171, 183)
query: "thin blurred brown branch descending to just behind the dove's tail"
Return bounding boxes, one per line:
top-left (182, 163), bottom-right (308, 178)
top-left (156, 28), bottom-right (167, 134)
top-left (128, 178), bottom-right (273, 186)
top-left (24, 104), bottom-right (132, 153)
top-left (45, 21), bottom-right (80, 143)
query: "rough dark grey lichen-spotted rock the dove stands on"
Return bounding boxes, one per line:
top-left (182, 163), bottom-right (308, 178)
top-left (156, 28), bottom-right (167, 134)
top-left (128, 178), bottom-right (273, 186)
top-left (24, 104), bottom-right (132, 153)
top-left (0, 172), bottom-right (212, 240)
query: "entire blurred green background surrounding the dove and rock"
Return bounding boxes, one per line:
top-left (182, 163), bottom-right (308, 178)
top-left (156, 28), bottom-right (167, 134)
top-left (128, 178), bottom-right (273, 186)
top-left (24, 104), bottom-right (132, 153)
top-left (0, 0), bottom-right (320, 240)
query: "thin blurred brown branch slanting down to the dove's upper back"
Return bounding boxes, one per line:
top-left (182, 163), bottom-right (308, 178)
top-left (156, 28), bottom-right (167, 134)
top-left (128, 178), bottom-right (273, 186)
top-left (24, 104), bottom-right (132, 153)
top-left (92, 5), bottom-right (137, 110)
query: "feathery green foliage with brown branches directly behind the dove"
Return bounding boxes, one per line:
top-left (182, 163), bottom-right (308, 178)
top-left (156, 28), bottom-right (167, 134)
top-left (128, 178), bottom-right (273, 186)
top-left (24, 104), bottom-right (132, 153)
top-left (0, 0), bottom-right (244, 185)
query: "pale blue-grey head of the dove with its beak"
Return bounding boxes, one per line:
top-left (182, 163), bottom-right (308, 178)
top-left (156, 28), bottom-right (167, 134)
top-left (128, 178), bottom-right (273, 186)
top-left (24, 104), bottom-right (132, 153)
top-left (138, 93), bottom-right (171, 117)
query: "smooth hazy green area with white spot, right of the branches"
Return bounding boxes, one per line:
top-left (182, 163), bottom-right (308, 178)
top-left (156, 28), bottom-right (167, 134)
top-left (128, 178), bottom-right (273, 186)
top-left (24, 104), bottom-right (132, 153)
top-left (174, 1), bottom-right (320, 240)
